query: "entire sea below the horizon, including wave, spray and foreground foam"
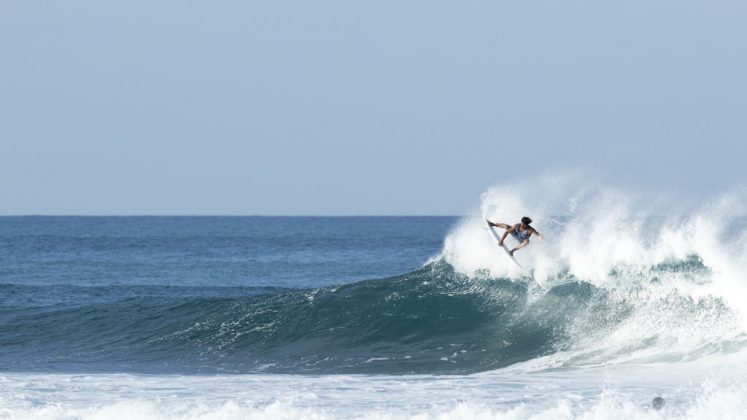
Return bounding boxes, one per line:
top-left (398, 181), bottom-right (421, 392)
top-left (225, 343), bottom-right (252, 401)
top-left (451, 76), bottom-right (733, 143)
top-left (0, 181), bottom-right (747, 419)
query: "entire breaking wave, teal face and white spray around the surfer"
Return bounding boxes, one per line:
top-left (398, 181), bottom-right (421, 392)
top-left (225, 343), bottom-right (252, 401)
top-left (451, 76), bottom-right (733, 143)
top-left (0, 176), bottom-right (747, 374)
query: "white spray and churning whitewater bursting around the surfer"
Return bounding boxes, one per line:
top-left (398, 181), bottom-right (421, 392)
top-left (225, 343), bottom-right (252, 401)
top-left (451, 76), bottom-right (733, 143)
top-left (440, 174), bottom-right (747, 363)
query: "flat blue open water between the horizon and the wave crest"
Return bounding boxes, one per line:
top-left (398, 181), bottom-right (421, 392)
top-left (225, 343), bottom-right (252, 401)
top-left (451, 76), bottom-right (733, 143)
top-left (0, 216), bottom-right (456, 288)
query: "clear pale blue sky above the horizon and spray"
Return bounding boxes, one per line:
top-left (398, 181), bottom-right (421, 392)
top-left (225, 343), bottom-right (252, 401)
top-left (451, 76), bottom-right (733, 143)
top-left (0, 0), bottom-right (747, 215)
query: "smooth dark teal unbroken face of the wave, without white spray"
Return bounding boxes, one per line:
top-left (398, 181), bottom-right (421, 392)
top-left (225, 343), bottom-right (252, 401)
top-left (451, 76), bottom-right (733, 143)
top-left (0, 263), bottom-right (556, 373)
